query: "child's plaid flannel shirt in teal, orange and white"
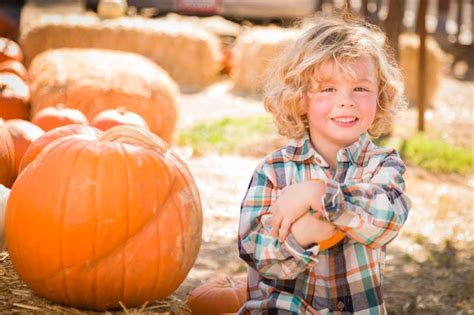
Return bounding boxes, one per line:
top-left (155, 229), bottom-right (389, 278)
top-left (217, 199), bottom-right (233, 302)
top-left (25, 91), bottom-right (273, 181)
top-left (238, 134), bottom-right (411, 314)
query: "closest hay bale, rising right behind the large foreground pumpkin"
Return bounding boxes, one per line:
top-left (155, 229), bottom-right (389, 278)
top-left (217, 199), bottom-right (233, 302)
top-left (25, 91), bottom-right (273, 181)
top-left (28, 48), bottom-right (177, 142)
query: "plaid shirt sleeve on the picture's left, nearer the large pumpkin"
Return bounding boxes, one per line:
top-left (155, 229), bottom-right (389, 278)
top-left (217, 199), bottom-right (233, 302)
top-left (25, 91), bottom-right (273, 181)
top-left (238, 165), bottom-right (319, 279)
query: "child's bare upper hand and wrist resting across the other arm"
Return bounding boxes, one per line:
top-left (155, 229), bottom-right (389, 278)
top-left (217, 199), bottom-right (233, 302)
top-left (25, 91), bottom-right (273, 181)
top-left (271, 180), bottom-right (326, 242)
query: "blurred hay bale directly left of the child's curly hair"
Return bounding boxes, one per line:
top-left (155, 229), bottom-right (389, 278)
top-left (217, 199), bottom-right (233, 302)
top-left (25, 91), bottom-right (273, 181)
top-left (231, 27), bottom-right (301, 95)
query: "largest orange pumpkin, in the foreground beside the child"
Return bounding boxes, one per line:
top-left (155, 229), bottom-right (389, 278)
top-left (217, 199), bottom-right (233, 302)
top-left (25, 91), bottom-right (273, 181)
top-left (6, 126), bottom-right (202, 310)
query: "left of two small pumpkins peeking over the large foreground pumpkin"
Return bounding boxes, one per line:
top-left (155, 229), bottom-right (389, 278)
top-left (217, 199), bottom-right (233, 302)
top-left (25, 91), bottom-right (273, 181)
top-left (31, 104), bottom-right (89, 131)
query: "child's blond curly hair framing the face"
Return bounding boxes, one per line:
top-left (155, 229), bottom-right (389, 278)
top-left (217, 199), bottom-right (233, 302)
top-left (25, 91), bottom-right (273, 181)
top-left (264, 16), bottom-right (406, 139)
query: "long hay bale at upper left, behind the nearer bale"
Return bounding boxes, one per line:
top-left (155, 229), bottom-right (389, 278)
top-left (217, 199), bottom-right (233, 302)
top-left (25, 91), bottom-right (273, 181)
top-left (20, 13), bottom-right (223, 91)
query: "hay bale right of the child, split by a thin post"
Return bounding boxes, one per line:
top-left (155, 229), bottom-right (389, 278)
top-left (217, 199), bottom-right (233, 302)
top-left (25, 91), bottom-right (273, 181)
top-left (398, 34), bottom-right (446, 105)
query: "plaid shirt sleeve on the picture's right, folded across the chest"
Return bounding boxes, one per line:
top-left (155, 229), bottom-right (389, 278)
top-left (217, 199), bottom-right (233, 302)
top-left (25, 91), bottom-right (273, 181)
top-left (322, 153), bottom-right (411, 248)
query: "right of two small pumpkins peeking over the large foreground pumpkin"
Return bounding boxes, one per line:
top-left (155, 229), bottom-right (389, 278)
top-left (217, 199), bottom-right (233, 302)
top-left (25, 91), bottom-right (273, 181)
top-left (91, 107), bottom-right (148, 131)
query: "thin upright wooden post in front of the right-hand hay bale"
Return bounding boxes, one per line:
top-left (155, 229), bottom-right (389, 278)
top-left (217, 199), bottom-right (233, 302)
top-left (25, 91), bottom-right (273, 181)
top-left (417, 0), bottom-right (427, 132)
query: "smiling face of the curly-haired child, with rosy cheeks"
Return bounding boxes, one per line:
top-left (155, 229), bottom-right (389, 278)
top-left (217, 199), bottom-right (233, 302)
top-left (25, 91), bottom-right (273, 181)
top-left (306, 57), bottom-right (378, 148)
